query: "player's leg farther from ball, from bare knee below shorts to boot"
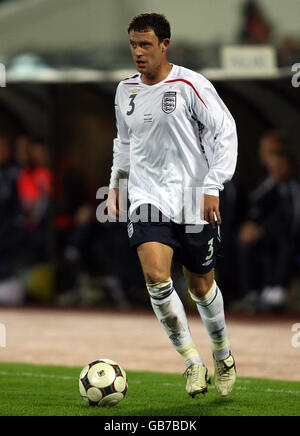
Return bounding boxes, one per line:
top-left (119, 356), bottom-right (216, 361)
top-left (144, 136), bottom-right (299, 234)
top-left (184, 267), bottom-right (236, 396)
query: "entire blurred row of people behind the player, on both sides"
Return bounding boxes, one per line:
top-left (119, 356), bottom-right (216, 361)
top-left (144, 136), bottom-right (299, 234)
top-left (0, 130), bottom-right (300, 313)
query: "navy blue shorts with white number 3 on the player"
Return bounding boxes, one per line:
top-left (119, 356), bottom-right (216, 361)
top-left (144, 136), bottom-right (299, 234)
top-left (127, 205), bottom-right (221, 274)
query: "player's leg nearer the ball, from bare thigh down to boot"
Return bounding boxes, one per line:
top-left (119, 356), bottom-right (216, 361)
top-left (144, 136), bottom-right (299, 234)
top-left (137, 242), bottom-right (207, 396)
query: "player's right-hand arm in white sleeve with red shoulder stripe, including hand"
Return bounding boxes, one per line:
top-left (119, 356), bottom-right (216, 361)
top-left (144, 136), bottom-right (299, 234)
top-left (192, 80), bottom-right (237, 227)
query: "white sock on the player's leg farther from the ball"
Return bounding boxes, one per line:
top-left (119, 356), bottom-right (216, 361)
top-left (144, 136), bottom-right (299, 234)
top-left (190, 282), bottom-right (230, 360)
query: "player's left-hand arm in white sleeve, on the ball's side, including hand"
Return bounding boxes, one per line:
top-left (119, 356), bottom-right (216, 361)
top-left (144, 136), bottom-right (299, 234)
top-left (106, 84), bottom-right (130, 220)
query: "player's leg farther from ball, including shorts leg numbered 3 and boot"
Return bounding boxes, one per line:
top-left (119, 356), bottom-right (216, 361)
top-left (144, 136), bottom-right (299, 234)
top-left (177, 225), bottom-right (236, 395)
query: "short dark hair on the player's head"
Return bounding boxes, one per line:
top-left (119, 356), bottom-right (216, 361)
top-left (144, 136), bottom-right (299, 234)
top-left (128, 13), bottom-right (171, 42)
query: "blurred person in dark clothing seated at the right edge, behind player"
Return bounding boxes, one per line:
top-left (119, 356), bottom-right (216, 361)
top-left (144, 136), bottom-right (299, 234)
top-left (234, 131), bottom-right (300, 311)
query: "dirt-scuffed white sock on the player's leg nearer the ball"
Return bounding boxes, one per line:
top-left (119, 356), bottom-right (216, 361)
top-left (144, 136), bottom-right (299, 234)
top-left (147, 278), bottom-right (203, 367)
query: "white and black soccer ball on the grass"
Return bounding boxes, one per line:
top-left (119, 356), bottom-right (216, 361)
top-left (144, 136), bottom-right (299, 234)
top-left (79, 359), bottom-right (128, 407)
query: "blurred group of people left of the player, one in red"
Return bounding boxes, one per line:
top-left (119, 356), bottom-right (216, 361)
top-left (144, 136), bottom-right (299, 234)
top-left (0, 134), bottom-right (142, 307)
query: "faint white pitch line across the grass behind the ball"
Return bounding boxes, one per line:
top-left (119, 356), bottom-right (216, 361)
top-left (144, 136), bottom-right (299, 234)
top-left (0, 371), bottom-right (300, 395)
